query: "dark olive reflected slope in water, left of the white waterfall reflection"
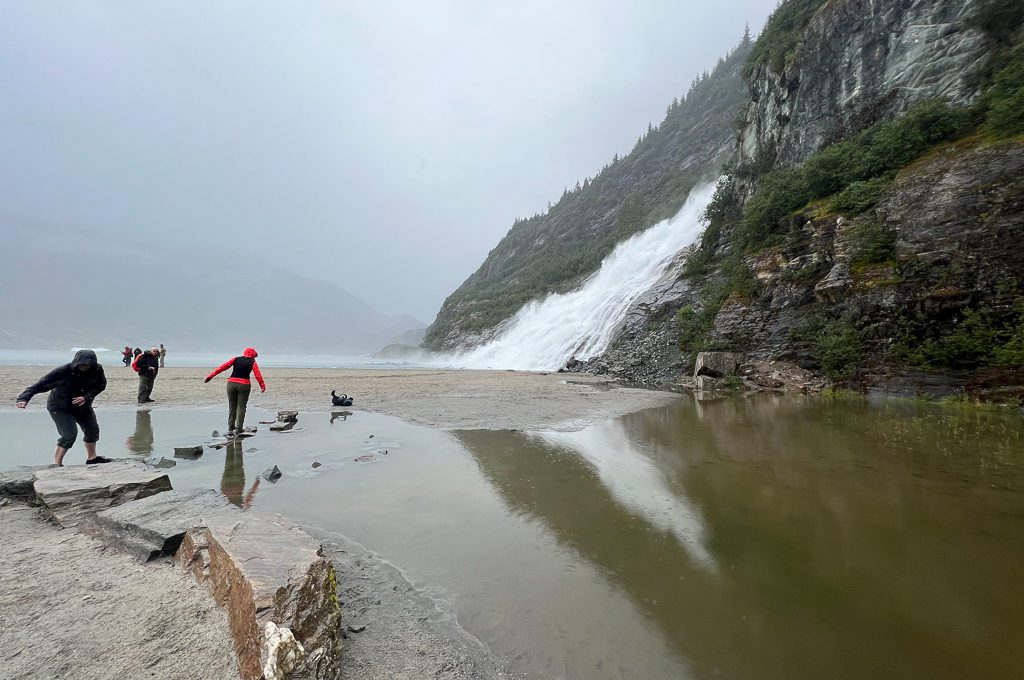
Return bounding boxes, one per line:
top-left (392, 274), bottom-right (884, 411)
top-left (454, 430), bottom-right (720, 680)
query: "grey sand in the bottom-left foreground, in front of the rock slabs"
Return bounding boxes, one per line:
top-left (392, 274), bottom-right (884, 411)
top-left (0, 503), bottom-right (239, 680)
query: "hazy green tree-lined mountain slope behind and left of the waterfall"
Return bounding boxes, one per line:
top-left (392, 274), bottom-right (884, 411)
top-left (424, 39), bottom-right (752, 349)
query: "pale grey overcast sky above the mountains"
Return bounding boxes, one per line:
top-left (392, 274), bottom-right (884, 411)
top-left (0, 0), bottom-right (775, 322)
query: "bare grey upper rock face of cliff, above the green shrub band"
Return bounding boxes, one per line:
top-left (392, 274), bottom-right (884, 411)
top-left (737, 0), bottom-right (988, 165)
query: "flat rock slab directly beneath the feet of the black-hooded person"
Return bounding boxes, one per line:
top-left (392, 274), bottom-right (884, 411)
top-left (33, 461), bottom-right (171, 526)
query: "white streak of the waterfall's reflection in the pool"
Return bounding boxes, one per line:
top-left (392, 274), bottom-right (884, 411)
top-left (532, 421), bottom-right (717, 570)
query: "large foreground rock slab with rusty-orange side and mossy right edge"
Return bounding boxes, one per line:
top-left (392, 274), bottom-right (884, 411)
top-left (175, 506), bottom-right (341, 680)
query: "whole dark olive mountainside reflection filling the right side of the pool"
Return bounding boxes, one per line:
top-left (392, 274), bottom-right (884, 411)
top-left (456, 395), bottom-right (1024, 680)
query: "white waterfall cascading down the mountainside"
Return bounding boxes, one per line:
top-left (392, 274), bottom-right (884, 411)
top-left (451, 183), bottom-right (715, 371)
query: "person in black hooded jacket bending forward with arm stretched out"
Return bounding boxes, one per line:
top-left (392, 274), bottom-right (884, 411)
top-left (16, 349), bottom-right (111, 465)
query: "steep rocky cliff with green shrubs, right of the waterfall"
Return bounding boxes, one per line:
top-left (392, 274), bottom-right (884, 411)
top-left (580, 0), bottom-right (1024, 398)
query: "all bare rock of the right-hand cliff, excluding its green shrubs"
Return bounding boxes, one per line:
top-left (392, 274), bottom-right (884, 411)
top-left (569, 0), bottom-right (1024, 399)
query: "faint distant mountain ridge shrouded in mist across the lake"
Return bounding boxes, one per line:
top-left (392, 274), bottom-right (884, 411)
top-left (0, 217), bottom-right (423, 354)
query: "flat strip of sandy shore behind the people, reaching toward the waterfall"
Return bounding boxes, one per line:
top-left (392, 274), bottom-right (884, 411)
top-left (0, 366), bottom-right (677, 429)
